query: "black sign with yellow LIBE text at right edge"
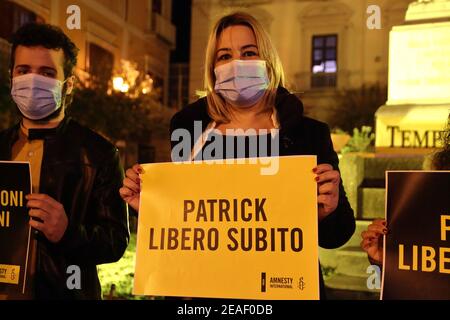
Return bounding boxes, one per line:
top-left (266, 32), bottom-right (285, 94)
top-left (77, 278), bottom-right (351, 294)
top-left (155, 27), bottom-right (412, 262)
top-left (382, 171), bottom-right (450, 300)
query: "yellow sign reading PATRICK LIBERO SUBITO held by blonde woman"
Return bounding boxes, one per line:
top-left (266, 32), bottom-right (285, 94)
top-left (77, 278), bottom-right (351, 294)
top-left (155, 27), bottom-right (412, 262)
top-left (134, 156), bottom-right (319, 300)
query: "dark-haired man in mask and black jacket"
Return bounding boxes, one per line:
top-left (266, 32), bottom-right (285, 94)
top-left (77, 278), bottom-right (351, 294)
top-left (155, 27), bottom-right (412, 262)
top-left (0, 24), bottom-right (129, 299)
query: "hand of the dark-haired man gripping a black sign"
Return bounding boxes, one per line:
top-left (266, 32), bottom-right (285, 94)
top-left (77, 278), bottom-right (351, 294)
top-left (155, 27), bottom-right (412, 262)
top-left (25, 193), bottom-right (68, 243)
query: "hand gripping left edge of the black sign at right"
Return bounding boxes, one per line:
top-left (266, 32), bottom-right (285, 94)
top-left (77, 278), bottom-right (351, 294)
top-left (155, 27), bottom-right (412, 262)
top-left (361, 219), bottom-right (387, 264)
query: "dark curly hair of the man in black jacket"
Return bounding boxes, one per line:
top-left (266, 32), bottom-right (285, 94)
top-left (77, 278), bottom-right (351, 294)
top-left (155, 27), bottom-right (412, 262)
top-left (9, 23), bottom-right (78, 78)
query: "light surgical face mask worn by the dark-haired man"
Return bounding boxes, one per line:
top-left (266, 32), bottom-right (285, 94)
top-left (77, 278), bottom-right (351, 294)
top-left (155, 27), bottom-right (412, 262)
top-left (11, 73), bottom-right (64, 120)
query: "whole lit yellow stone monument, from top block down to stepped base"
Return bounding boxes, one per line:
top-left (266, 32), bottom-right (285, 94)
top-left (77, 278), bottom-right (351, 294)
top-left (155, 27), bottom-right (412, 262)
top-left (320, 0), bottom-right (450, 299)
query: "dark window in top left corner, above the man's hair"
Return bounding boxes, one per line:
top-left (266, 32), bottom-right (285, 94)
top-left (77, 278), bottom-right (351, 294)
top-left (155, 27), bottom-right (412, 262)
top-left (0, 0), bottom-right (44, 40)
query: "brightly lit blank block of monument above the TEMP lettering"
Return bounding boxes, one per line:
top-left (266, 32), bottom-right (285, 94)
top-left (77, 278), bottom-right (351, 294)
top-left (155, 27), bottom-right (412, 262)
top-left (387, 22), bottom-right (450, 105)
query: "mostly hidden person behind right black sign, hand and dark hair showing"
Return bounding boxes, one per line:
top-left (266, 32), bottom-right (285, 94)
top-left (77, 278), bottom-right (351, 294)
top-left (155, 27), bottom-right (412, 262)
top-left (361, 114), bottom-right (450, 266)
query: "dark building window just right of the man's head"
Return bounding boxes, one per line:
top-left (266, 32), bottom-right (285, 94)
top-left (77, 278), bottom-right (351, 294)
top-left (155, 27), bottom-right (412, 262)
top-left (89, 43), bottom-right (114, 88)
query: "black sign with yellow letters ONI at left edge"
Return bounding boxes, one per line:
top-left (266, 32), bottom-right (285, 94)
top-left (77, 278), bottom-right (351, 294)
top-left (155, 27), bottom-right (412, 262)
top-left (0, 161), bottom-right (31, 297)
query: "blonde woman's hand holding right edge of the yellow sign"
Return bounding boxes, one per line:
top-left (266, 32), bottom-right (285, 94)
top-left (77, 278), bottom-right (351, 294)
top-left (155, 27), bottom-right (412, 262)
top-left (313, 164), bottom-right (341, 222)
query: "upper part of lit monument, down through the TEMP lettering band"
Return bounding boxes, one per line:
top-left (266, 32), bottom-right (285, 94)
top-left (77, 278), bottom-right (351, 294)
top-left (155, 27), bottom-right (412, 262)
top-left (375, 0), bottom-right (450, 154)
